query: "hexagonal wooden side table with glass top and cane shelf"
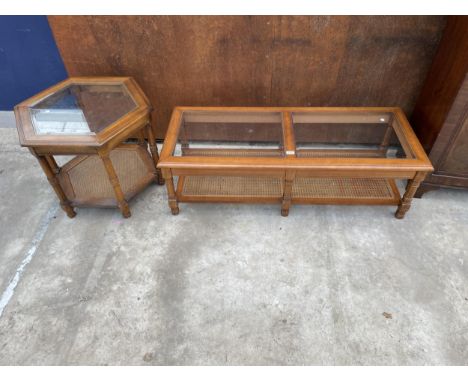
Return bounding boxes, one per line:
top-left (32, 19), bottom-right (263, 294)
top-left (15, 77), bottom-right (164, 218)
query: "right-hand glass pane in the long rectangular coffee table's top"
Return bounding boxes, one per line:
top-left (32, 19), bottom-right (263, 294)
top-left (292, 112), bottom-right (412, 158)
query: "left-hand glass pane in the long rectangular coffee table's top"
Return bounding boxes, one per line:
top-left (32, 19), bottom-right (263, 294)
top-left (174, 111), bottom-right (283, 157)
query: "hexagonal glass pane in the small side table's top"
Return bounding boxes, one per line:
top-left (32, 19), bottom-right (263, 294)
top-left (31, 84), bottom-right (137, 135)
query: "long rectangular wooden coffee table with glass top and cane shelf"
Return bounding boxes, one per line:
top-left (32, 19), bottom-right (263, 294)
top-left (158, 107), bottom-right (433, 219)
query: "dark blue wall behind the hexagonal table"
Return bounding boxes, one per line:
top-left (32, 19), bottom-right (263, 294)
top-left (0, 16), bottom-right (67, 110)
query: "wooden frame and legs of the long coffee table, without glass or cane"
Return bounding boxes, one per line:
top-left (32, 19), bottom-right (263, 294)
top-left (158, 107), bottom-right (433, 219)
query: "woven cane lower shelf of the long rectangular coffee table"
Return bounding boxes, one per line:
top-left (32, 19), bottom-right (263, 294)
top-left (177, 176), bottom-right (400, 204)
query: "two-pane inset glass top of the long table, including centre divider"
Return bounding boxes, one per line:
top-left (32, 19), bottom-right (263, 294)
top-left (173, 108), bottom-right (413, 159)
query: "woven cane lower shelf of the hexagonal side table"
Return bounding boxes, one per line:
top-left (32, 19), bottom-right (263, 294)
top-left (58, 144), bottom-right (154, 207)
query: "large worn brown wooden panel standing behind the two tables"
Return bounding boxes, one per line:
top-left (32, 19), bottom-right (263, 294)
top-left (49, 16), bottom-right (445, 138)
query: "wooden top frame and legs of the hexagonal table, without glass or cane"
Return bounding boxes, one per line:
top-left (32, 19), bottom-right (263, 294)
top-left (15, 77), bottom-right (164, 218)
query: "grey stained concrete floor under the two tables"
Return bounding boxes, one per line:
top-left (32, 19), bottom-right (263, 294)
top-left (0, 119), bottom-right (468, 365)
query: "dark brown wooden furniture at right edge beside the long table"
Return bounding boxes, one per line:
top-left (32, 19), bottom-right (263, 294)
top-left (412, 16), bottom-right (468, 197)
